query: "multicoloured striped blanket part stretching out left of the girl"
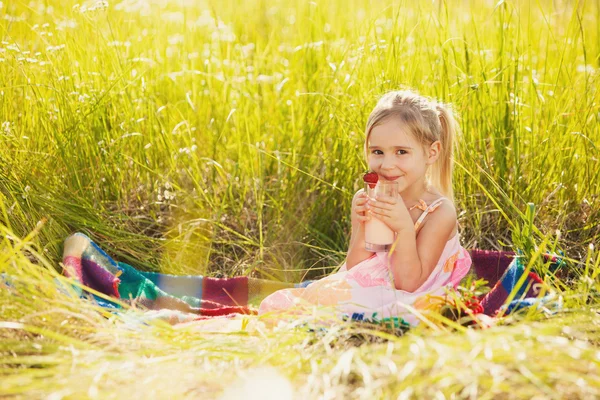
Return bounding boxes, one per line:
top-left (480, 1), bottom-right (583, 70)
top-left (63, 233), bottom-right (294, 317)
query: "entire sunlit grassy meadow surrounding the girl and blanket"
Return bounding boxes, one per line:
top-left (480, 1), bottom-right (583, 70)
top-left (0, 0), bottom-right (600, 399)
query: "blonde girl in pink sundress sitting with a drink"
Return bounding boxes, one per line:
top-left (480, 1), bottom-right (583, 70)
top-left (259, 91), bottom-right (471, 325)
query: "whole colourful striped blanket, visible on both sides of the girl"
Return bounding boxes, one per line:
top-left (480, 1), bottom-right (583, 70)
top-left (63, 233), bottom-right (556, 323)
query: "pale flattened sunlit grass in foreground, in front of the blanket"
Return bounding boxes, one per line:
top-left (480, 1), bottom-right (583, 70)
top-left (0, 222), bottom-right (600, 399)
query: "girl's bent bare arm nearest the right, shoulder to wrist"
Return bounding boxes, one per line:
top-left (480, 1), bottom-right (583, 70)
top-left (390, 203), bottom-right (456, 292)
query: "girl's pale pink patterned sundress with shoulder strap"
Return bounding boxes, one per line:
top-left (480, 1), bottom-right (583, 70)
top-left (258, 198), bottom-right (471, 325)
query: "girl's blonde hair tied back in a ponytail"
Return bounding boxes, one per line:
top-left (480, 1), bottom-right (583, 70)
top-left (365, 90), bottom-right (458, 200)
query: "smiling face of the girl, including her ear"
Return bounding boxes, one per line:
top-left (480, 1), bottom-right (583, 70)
top-left (367, 118), bottom-right (439, 193)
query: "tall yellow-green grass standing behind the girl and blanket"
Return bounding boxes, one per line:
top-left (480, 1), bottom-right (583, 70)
top-left (0, 1), bottom-right (600, 279)
